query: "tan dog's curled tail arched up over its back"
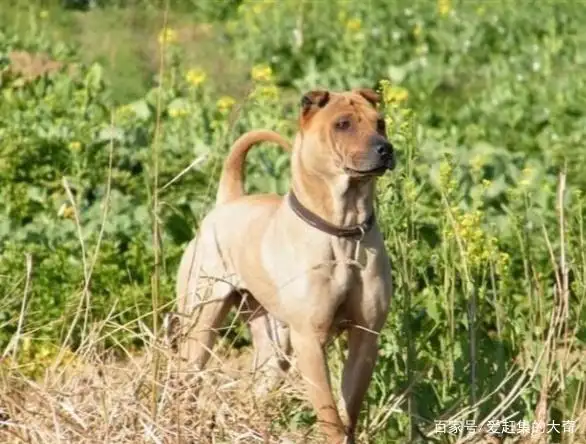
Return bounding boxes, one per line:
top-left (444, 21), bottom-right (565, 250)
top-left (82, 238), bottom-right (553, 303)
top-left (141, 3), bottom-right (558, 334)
top-left (216, 130), bottom-right (291, 205)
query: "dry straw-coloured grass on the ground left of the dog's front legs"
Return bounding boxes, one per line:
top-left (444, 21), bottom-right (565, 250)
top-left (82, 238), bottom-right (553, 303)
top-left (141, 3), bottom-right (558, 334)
top-left (0, 338), bottom-right (315, 443)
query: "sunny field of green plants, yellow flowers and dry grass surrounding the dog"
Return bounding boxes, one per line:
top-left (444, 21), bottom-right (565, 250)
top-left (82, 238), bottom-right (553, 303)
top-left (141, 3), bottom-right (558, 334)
top-left (0, 0), bottom-right (586, 444)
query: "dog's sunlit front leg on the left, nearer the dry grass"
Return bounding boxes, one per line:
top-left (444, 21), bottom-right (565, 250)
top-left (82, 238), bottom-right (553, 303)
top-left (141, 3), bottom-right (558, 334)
top-left (291, 329), bottom-right (346, 444)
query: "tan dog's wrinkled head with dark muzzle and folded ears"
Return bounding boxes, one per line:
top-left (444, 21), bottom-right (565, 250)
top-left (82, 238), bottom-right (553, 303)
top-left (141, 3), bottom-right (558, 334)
top-left (299, 89), bottom-right (395, 178)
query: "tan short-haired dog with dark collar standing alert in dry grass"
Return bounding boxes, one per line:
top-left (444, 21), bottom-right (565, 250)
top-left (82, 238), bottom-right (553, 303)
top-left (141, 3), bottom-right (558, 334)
top-left (177, 90), bottom-right (395, 444)
